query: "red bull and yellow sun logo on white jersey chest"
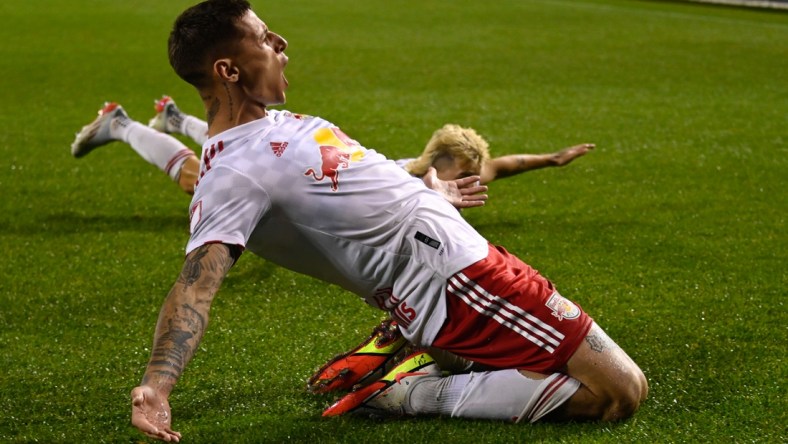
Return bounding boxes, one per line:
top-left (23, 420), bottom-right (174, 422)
top-left (304, 128), bottom-right (364, 191)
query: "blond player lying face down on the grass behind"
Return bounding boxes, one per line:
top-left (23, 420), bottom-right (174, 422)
top-left (71, 96), bottom-right (594, 194)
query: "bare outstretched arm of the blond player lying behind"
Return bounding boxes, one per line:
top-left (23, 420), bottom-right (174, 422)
top-left (481, 143), bottom-right (595, 184)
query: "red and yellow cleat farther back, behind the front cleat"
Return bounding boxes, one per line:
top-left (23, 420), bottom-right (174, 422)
top-left (307, 319), bottom-right (408, 393)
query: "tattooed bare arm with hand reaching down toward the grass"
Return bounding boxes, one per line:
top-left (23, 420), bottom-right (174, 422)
top-left (131, 244), bottom-right (234, 442)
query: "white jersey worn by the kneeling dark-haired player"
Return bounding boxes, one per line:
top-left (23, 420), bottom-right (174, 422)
top-left (186, 111), bottom-right (487, 345)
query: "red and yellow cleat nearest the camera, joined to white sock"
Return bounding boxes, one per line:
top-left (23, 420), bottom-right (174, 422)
top-left (323, 351), bottom-right (441, 416)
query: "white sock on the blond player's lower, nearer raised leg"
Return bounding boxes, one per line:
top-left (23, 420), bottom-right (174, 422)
top-left (113, 121), bottom-right (195, 181)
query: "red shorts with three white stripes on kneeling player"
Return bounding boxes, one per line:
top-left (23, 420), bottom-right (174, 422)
top-left (432, 245), bottom-right (593, 373)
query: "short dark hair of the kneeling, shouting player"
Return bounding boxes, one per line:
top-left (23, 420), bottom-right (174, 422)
top-left (167, 0), bottom-right (252, 88)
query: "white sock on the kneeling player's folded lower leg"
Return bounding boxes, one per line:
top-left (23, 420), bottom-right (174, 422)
top-left (405, 369), bottom-right (580, 422)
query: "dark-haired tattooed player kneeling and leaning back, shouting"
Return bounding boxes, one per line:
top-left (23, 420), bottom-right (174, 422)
top-left (131, 0), bottom-right (648, 441)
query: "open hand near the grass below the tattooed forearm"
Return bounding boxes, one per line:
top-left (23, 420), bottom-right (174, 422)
top-left (131, 386), bottom-right (181, 442)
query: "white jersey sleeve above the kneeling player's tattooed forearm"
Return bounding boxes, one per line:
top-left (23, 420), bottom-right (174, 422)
top-left (186, 167), bottom-right (271, 254)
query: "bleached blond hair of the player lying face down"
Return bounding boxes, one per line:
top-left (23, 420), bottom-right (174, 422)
top-left (405, 123), bottom-right (490, 176)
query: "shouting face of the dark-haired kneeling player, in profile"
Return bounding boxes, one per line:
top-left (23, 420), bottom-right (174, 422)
top-left (235, 10), bottom-right (287, 106)
